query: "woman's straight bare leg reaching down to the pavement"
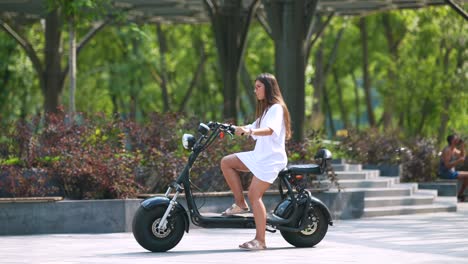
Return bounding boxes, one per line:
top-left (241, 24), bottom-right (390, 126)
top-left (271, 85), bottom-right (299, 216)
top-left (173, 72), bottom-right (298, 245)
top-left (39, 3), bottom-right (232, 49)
top-left (245, 176), bottom-right (271, 246)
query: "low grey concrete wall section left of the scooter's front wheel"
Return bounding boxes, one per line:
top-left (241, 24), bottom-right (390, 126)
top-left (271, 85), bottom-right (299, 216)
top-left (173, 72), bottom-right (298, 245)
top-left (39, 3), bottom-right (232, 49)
top-left (0, 199), bottom-right (140, 235)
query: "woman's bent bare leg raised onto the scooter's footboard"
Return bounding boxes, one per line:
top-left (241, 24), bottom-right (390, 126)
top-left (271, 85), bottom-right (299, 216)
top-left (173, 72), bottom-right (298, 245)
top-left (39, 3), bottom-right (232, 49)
top-left (221, 154), bottom-right (249, 208)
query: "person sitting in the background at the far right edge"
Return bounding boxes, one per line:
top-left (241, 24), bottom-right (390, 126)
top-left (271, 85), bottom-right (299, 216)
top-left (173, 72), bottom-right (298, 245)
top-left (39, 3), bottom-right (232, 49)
top-left (439, 135), bottom-right (468, 202)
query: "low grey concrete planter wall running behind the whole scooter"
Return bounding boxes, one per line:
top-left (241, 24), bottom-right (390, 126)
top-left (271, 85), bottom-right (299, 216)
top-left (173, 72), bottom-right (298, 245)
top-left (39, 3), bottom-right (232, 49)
top-left (0, 192), bottom-right (364, 235)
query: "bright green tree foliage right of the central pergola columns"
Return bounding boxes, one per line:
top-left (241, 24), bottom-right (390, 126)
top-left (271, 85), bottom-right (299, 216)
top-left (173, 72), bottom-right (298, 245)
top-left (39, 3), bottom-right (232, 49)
top-left (309, 7), bottom-right (468, 142)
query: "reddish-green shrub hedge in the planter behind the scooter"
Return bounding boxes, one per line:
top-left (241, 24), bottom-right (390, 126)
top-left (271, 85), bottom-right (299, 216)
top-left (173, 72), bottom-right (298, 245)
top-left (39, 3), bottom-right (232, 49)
top-left (0, 112), bottom-right (334, 199)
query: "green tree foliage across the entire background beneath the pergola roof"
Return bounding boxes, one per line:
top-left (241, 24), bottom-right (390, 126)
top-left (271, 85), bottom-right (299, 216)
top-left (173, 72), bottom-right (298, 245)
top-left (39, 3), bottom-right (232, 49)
top-left (0, 5), bottom-right (468, 141)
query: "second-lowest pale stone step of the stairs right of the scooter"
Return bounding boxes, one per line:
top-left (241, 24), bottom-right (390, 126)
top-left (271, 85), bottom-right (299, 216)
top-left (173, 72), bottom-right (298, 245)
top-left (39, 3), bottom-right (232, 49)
top-left (364, 195), bottom-right (434, 208)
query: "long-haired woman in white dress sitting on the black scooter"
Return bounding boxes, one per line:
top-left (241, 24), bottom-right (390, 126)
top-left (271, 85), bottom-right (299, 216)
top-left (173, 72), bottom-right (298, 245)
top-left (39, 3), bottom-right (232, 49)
top-left (221, 73), bottom-right (291, 250)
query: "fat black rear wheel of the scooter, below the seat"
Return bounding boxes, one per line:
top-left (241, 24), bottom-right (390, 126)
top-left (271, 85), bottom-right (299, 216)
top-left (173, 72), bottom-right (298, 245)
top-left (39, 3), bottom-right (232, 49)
top-left (281, 208), bottom-right (328, 247)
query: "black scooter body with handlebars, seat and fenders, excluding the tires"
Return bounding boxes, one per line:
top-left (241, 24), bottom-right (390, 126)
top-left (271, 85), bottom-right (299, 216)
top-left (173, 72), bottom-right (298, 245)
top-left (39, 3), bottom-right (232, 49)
top-left (141, 123), bottom-right (333, 232)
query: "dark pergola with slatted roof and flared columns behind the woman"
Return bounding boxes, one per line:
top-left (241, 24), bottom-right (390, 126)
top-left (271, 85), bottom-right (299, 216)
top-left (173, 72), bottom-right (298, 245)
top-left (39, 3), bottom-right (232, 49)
top-left (0, 0), bottom-right (468, 140)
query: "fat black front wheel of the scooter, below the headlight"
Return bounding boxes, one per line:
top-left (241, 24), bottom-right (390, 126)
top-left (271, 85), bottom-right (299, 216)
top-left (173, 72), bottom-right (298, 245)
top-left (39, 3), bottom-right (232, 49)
top-left (132, 206), bottom-right (185, 252)
